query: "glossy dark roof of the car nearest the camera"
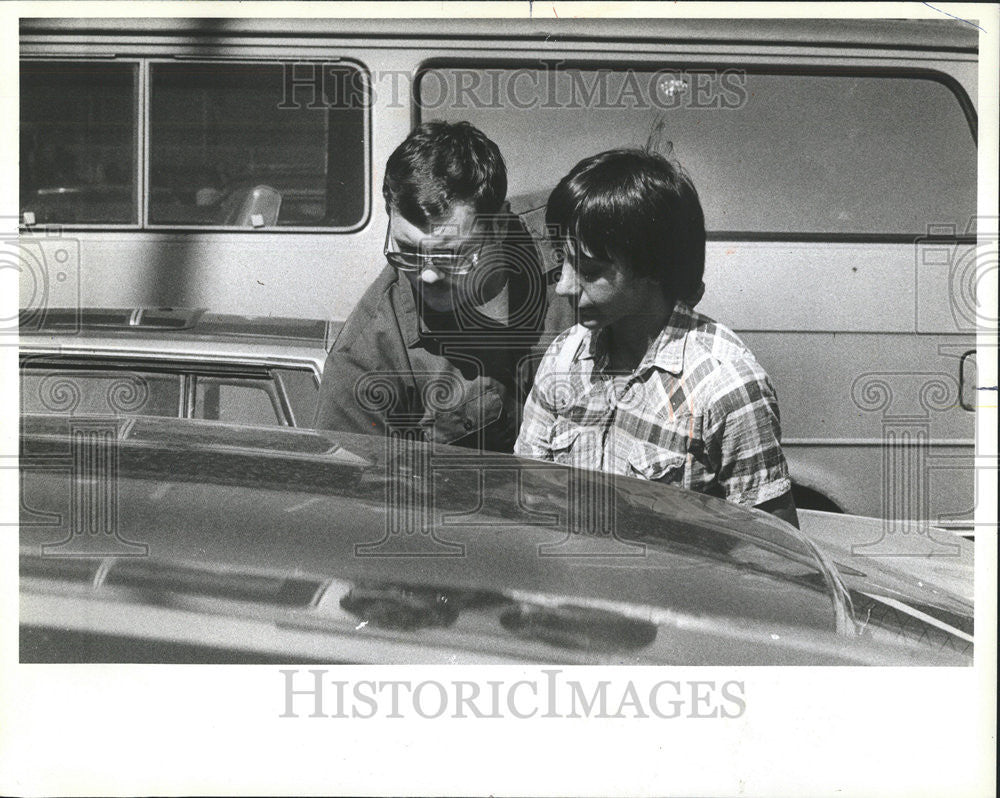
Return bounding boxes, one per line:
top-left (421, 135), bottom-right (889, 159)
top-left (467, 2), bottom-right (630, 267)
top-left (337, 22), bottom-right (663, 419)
top-left (20, 415), bottom-right (966, 664)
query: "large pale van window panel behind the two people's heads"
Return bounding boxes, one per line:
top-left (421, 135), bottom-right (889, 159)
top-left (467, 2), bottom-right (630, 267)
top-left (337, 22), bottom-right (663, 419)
top-left (419, 66), bottom-right (976, 234)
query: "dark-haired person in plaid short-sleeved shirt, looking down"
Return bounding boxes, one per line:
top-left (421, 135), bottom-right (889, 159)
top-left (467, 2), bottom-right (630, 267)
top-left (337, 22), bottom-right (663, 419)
top-left (514, 150), bottom-right (798, 526)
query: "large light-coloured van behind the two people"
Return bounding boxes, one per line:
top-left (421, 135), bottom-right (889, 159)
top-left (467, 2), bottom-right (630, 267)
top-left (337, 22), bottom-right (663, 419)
top-left (19, 19), bottom-right (978, 534)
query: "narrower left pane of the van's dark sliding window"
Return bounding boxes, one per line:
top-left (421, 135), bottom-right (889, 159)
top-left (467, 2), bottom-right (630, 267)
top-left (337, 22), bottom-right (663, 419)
top-left (20, 61), bottom-right (138, 224)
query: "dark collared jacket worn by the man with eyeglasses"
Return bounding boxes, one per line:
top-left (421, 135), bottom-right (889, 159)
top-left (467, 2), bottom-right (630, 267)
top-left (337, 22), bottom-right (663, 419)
top-left (314, 215), bottom-right (572, 452)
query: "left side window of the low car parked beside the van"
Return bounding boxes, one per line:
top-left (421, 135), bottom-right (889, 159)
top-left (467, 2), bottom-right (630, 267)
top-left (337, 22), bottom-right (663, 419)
top-left (21, 368), bottom-right (181, 418)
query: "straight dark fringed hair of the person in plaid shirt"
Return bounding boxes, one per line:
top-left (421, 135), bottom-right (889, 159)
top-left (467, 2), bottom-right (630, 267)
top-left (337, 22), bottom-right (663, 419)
top-left (545, 150), bottom-right (705, 299)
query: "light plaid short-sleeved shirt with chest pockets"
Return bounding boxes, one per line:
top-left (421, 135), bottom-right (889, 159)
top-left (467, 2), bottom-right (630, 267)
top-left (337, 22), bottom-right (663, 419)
top-left (514, 303), bottom-right (791, 507)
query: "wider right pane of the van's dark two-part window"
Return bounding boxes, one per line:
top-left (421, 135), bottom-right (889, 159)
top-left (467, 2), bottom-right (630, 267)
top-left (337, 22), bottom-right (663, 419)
top-left (149, 63), bottom-right (366, 227)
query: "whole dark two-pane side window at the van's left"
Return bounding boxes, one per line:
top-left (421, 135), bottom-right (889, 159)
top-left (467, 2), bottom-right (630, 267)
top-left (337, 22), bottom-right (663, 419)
top-left (20, 58), bottom-right (369, 231)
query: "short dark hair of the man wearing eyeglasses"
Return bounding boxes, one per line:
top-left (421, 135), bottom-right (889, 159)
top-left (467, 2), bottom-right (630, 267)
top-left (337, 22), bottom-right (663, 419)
top-left (382, 121), bottom-right (507, 227)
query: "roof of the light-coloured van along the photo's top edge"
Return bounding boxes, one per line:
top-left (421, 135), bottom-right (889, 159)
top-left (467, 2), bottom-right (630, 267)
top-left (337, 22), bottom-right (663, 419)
top-left (21, 14), bottom-right (979, 52)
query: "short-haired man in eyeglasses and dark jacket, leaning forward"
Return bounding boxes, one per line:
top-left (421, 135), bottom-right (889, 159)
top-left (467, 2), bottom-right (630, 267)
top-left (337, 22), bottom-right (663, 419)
top-left (314, 122), bottom-right (546, 452)
